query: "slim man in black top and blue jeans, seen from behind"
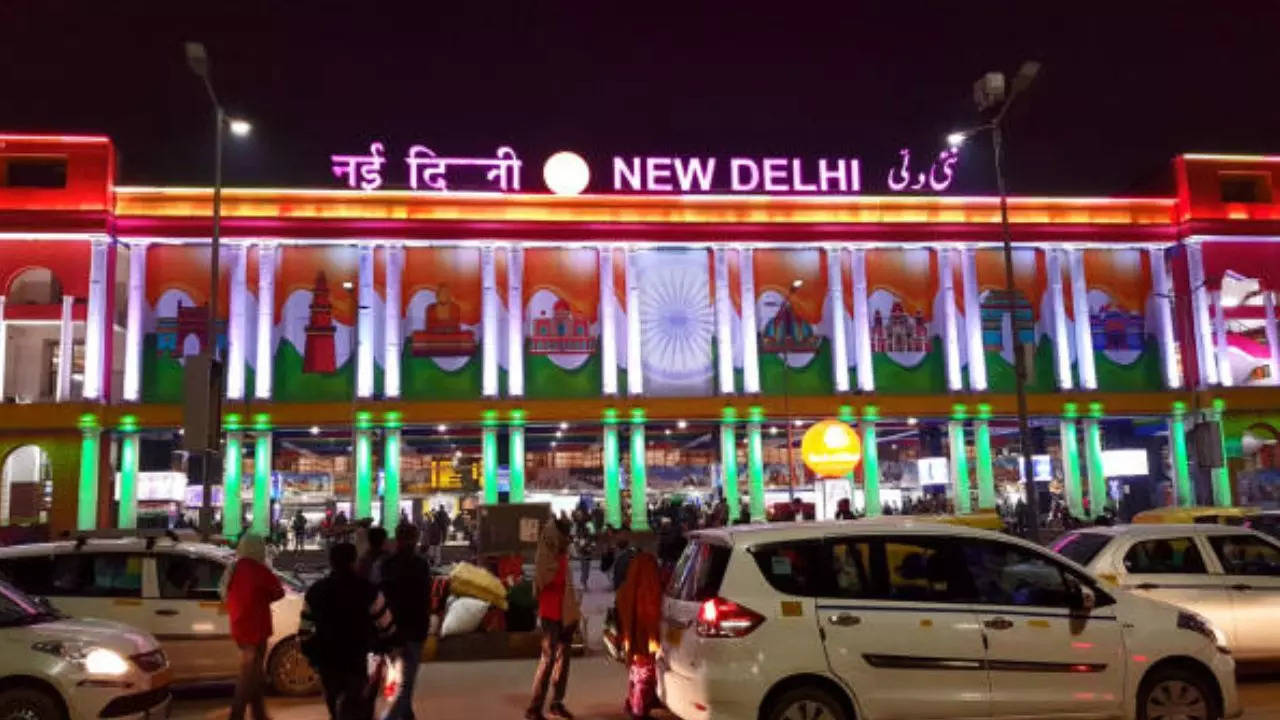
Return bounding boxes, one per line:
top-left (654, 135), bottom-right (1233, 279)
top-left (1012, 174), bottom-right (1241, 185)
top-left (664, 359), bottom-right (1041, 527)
top-left (379, 523), bottom-right (431, 720)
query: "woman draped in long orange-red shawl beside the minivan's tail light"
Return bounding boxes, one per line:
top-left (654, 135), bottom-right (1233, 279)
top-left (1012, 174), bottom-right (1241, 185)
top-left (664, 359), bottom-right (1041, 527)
top-left (616, 551), bottom-right (662, 719)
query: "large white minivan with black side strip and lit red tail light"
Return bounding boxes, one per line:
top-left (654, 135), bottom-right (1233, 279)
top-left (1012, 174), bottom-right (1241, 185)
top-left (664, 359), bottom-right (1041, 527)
top-left (657, 518), bottom-right (1240, 720)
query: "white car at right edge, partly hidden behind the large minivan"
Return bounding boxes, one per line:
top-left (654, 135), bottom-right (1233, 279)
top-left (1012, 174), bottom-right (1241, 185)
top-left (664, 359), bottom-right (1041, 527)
top-left (1053, 524), bottom-right (1280, 662)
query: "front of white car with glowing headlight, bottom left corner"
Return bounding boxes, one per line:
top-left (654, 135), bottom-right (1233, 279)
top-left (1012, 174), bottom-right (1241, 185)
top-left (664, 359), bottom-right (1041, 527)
top-left (0, 571), bottom-right (169, 720)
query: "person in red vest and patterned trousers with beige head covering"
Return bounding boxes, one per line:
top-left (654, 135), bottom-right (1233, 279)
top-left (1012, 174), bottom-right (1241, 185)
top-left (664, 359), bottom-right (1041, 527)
top-left (525, 518), bottom-right (581, 720)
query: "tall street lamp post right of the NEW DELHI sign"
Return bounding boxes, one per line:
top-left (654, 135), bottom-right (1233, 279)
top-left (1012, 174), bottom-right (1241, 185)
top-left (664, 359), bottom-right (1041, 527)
top-left (947, 60), bottom-right (1041, 542)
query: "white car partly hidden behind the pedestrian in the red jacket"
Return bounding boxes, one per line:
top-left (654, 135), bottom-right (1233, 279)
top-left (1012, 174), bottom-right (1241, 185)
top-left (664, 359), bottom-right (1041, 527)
top-left (0, 538), bottom-right (319, 694)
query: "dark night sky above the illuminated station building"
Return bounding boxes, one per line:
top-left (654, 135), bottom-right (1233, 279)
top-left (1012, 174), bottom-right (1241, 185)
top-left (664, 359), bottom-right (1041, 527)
top-left (0, 0), bottom-right (1280, 195)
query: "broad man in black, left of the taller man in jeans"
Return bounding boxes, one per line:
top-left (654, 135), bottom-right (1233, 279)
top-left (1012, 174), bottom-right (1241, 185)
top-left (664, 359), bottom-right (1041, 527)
top-left (298, 542), bottom-right (396, 720)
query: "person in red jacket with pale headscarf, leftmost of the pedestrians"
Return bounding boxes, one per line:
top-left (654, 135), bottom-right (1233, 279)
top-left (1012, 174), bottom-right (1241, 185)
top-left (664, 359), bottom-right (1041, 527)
top-left (220, 533), bottom-right (284, 720)
